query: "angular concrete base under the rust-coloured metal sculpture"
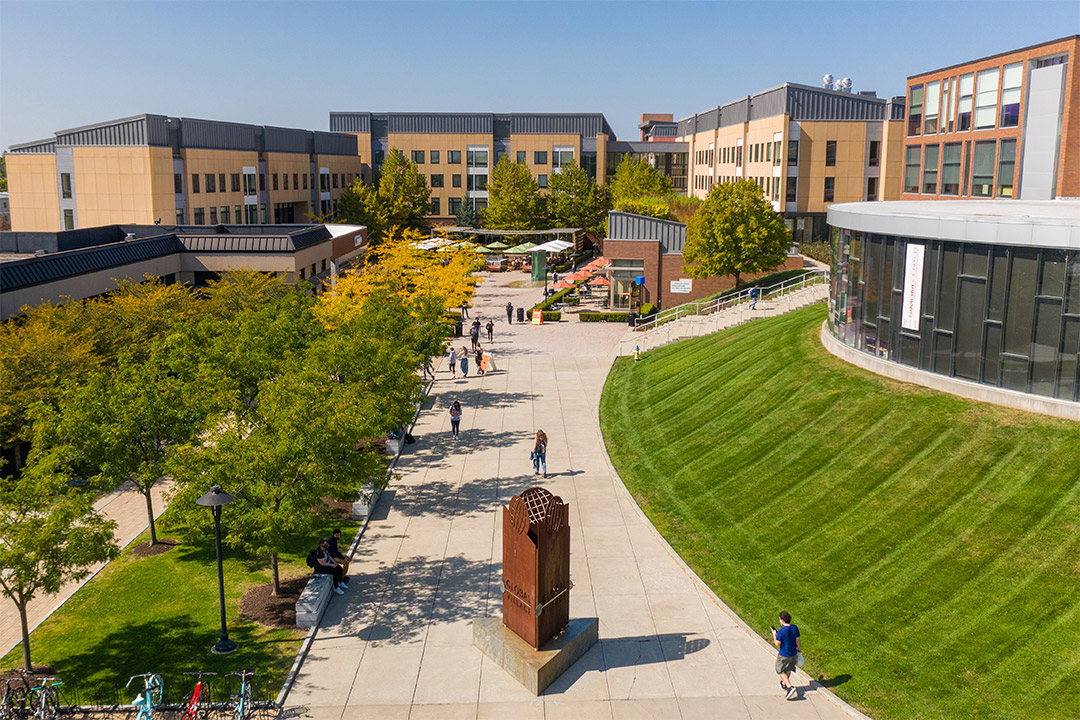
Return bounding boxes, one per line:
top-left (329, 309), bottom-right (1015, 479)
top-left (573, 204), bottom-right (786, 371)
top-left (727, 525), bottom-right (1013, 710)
top-left (473, 617), bottom-right (599, 695)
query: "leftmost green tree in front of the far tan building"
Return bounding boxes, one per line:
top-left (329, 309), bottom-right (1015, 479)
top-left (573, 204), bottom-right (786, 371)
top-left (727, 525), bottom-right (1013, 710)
top-left (338, 148), bottom-right (431, 246)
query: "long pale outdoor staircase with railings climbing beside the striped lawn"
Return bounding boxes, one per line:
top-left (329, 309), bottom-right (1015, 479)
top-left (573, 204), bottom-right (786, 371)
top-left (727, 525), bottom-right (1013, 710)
top-left (618, 271), bottom-right (828, 355)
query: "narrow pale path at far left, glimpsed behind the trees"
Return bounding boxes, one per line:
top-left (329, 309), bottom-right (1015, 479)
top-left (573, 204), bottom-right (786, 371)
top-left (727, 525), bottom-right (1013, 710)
top-left (0, 480), bottom-right (172, 657)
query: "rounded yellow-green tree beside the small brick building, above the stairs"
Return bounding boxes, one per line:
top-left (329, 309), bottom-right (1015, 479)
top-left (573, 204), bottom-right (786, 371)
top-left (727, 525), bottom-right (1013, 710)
top-left (683, 180), bottom-right (792, 287)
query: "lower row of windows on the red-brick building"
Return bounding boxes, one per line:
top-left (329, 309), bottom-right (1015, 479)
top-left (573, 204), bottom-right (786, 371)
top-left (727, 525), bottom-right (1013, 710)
top-left (904, 138), bottom-right (1016, 198)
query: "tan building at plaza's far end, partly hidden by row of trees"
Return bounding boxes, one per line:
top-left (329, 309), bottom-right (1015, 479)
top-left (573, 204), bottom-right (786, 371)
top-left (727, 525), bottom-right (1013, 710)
top-left (330, 112), bottom-right (686, 221)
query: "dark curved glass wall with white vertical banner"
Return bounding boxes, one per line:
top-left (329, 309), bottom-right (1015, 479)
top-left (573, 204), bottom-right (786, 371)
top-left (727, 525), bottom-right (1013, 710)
top-left (828, 228), bottom-right (1080, 402)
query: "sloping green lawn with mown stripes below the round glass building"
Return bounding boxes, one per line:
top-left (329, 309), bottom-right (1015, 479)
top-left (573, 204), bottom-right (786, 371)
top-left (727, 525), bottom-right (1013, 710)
top-left (600, 304), bottom-right (1080, 720)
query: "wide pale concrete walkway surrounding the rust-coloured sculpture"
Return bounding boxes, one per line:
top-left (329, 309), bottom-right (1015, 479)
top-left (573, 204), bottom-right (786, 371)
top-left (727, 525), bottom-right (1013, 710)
top-left (286, 276), bottom-right (850, 720)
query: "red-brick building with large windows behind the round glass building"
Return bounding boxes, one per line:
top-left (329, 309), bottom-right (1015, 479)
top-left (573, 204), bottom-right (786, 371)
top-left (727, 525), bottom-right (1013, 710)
top-left (901, 35), bottom-right (1080, 200)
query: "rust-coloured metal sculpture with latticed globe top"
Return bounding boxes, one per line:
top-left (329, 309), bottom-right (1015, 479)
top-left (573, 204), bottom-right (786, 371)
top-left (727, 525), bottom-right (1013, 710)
top-left (502, 487), bottom-right (570, 650)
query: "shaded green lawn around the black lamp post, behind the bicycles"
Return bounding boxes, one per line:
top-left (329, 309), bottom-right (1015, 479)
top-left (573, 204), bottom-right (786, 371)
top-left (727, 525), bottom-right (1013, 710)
top-left (0, 510), bottom-right (359, 702)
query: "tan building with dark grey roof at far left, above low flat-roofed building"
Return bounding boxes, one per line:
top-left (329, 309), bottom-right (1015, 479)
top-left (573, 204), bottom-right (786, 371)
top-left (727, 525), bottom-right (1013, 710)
top-left (6, 114), bottom-right (363, 231)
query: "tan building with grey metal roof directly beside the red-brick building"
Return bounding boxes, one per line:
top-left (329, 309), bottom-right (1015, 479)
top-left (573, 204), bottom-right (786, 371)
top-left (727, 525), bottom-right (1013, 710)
top-left (677, 84), bottom-right (904, 242)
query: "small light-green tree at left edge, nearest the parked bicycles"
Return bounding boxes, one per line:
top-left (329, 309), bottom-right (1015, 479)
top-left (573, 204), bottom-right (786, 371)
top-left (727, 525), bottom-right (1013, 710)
top-left (0, 444), bottom-right (120, 673)
